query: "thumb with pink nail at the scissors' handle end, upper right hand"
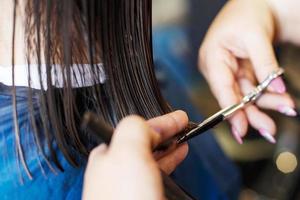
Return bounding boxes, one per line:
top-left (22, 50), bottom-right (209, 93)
top-left (246, 33), bottom-right (286, 94)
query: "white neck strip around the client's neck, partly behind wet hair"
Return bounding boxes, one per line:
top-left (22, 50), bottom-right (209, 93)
top-left (0, 64), bottom-right (106, 90)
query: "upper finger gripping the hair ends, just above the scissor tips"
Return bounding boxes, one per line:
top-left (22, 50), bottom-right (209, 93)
top-left (147, 110), bottom-right (189, 141)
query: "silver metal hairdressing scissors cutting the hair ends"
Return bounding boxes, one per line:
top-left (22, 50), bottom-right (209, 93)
top-left (177, 68), bottom-right (284, 144)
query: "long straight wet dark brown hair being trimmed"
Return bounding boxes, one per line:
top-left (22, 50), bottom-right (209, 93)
top-left (12, 0), bottom-right (170, 178)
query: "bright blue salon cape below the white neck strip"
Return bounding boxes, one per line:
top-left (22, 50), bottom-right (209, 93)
top-left (0, 84), bottom-right (84, 200)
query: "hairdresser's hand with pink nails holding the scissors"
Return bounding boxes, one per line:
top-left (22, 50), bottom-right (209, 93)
top-left (199, 0), bottom-right (296, 143)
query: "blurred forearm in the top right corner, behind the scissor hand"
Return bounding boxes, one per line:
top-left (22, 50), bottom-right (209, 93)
top-left (266, 0), bottom-right (300, 45)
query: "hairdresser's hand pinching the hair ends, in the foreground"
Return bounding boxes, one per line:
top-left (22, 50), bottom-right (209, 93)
top-left (83, 111), bottom-right (188, 200)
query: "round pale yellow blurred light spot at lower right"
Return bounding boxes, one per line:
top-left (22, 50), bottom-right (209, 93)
top-left (276, 151), bottom-right (298, 174)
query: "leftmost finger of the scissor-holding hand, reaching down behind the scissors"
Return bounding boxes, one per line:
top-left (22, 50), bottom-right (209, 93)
top-left (201, 49), bottom-right (248, 144)
